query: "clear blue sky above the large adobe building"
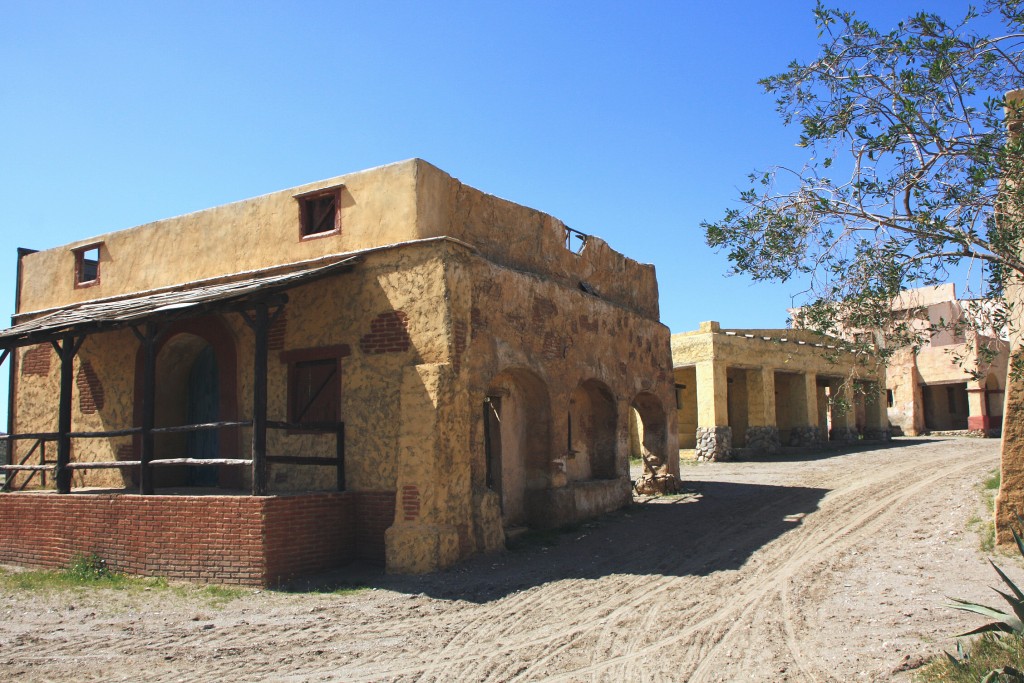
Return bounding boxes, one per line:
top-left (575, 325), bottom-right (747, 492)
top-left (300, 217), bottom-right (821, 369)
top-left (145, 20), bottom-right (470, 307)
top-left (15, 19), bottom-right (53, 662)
top-left (0, 0), bottom-right (991, 411)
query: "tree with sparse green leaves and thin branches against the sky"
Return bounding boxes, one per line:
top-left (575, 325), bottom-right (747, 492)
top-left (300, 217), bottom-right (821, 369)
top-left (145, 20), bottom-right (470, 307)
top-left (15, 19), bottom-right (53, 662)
top-left (702, 0), bottom-right (1024, 374)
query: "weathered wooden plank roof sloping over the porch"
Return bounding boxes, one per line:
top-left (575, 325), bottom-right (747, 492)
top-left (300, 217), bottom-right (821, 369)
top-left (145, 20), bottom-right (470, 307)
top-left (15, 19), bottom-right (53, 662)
top-left (0, 256), bottom-right (360, 348)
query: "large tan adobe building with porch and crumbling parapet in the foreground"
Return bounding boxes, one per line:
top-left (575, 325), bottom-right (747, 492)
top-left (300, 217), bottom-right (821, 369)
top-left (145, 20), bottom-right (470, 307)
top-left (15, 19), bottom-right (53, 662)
top-left (0, 160), bottom-right (678, 584)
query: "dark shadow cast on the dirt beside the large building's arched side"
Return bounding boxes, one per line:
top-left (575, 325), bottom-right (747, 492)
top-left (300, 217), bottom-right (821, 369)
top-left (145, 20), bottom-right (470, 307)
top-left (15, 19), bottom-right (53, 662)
top-left (280, 481), bottom-right (828, 602)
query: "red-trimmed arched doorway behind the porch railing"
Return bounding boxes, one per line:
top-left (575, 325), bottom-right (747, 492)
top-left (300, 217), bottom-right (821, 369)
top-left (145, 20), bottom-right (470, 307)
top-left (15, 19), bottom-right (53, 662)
top-left (134, 317), bottom-right (244, 488)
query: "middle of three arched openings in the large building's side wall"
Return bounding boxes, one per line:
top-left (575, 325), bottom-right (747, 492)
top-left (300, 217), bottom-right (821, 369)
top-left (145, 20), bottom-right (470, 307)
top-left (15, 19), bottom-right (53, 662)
top-left (565, 380), bottom-right (617, 481)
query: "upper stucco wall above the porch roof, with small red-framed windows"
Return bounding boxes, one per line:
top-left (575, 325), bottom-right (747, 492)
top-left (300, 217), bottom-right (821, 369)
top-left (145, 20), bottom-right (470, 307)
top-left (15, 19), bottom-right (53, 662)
top-left (18, 159), bottom-right (658, 318)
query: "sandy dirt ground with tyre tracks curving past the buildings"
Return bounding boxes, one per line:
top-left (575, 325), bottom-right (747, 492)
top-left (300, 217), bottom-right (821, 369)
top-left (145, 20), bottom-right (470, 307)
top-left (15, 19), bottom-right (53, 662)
top-left (0, 438), bottom-right (1011, 681)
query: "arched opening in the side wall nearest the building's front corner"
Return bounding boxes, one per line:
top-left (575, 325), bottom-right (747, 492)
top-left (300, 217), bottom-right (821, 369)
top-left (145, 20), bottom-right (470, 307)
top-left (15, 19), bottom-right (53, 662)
top-left (483, 369), bottom-right (551, 526)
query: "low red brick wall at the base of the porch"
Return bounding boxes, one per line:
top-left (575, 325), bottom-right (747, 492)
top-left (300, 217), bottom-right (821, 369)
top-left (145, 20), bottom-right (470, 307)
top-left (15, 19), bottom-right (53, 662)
top-left (0, 492), bottom-right (394, 586)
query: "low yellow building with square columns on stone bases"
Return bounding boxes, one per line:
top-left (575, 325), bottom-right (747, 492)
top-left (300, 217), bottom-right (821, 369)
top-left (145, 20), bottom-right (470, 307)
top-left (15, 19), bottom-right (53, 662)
top-left (672, 322), bottom-right (889, 460)
